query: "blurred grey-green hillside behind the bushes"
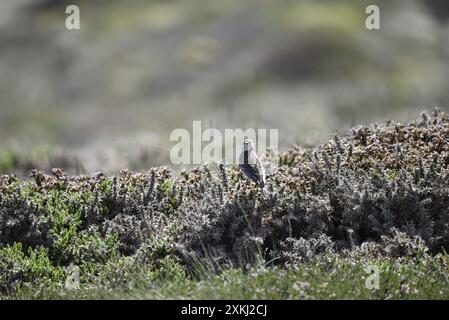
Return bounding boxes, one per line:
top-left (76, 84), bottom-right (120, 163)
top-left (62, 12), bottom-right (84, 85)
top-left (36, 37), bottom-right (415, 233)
top-left (0, 0), bottom-right (449, 175)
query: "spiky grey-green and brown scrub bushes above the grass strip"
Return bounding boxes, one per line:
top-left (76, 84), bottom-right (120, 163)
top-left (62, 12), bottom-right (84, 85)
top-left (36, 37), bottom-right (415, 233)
top-left (0, 111), bottom-right (449, 293)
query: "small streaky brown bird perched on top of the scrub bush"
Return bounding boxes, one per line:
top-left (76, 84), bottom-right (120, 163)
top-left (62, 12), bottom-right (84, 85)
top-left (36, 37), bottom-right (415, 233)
top-left (239, 138), bottom-right (266, 195)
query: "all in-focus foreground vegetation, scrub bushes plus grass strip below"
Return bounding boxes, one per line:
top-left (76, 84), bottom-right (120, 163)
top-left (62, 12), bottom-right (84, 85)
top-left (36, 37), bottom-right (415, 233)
top-left (0, 110), bottom-right (449, 298)
